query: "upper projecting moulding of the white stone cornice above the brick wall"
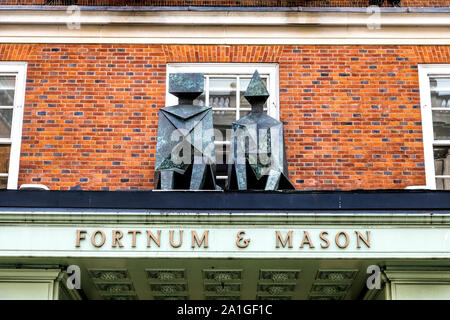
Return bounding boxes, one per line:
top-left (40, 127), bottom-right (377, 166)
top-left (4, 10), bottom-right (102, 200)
top-left (0, 8), bottom-right (450, 27)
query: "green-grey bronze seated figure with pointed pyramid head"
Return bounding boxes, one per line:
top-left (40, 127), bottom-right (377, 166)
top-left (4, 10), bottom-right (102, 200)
top-left (227, 71), bottom-right (295, 190)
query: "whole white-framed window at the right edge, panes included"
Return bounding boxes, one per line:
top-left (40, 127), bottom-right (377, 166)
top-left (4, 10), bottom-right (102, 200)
top-left (419, 65), bottom-right (450, 190)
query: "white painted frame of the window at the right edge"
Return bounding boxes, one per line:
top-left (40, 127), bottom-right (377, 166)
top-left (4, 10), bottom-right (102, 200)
top-left (418, 64), bottom-right (450, 190)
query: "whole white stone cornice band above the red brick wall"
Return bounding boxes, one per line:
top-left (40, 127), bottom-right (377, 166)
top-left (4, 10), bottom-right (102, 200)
top-left (0, 10), bottom-right (450, 45)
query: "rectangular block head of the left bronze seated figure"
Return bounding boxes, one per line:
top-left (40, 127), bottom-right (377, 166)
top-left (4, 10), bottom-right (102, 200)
top-left (169, 73), bottom-right (205, 105)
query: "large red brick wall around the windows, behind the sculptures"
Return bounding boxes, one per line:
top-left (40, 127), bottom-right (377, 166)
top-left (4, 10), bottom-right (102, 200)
top-left (0, 44), bottom-right (450, 190)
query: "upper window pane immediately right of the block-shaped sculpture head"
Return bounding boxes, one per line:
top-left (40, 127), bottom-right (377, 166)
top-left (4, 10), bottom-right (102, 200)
top-left (209, 78), bottom-right (236, 109)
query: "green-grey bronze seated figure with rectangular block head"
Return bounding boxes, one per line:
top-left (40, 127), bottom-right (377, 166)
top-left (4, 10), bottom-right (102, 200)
top-left (155, 73), bottom-right (218, 190)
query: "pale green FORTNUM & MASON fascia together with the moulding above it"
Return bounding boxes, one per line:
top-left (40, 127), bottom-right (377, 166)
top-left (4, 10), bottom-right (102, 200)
top-left (0, 208), bottom-right (450, 259)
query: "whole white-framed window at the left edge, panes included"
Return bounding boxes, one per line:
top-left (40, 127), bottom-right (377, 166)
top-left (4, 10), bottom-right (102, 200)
top-left (0, 62), bottom-right (27, 189)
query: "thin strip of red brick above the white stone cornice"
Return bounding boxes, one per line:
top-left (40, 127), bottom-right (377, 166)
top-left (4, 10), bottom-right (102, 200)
top-left (0, 0), bottom-right (450, 7)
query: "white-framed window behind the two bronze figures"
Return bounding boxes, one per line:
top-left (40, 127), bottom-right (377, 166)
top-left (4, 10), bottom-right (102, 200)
top-left (166, 63), bottom-right (279, 188)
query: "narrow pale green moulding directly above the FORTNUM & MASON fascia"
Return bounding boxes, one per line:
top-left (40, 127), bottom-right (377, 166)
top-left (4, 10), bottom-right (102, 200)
top-left (0, 209), bottom-right (450, 227)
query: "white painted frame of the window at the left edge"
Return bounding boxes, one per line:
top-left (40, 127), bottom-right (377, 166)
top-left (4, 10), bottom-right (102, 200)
top-left (0, 61), bottom-right (27, 189)
